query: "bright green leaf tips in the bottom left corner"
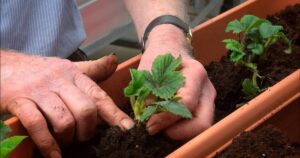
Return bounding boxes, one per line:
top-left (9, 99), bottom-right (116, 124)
top-left (0, 120), bottom-right (26, 158)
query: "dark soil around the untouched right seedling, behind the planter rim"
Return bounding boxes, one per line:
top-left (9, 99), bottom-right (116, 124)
top-left (206, 4), bottom-right (300, 122)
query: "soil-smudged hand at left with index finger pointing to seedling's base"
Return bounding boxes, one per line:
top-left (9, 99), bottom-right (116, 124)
top-left (0, 50), bottom-right (133, 157)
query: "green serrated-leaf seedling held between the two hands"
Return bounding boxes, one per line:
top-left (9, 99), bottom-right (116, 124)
top-left (124, 54), bottom-right (192, 123)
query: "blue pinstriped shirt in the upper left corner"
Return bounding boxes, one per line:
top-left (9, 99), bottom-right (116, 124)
top-left (0, 0), bottom-right (86, 58)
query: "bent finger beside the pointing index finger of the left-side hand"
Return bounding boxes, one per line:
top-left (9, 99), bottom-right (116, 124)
top-left (56, 81), bottom-right (97, 141)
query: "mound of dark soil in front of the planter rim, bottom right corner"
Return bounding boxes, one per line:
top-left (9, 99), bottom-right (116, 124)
top-left (215, 125), bottom-right (300, 158)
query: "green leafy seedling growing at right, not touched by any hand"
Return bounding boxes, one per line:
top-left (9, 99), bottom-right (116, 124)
top-left (223, 15), bottom-right (292, 100)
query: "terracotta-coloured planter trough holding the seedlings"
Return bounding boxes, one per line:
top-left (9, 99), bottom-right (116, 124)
top-left (6, 0), bottom-right (300, 158)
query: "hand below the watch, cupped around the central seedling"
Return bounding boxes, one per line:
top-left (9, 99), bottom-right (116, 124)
top-left (139, 26), bottom-right (216, 140)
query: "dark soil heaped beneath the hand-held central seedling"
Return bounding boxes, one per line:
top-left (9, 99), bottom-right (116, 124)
top-left (33, 105), bottom-right (183, 158)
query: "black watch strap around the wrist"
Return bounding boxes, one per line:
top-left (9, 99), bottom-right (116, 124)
top-left (141, 15), bottom-right (192, 53)
